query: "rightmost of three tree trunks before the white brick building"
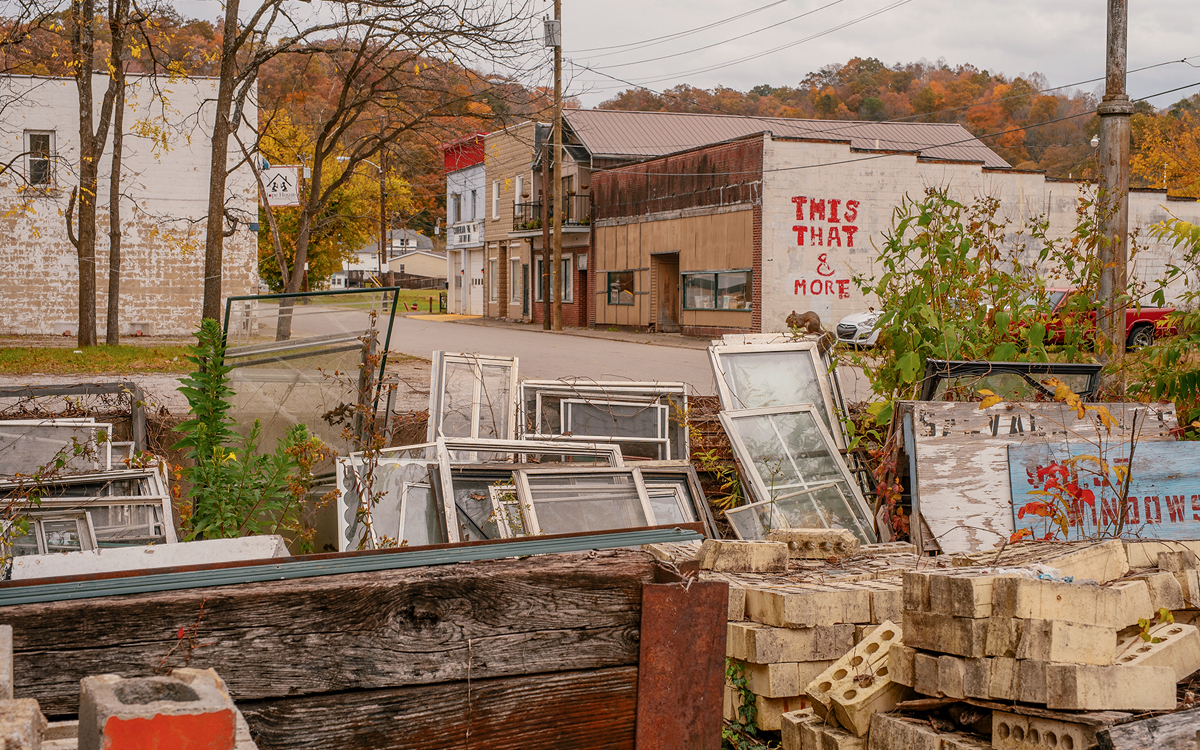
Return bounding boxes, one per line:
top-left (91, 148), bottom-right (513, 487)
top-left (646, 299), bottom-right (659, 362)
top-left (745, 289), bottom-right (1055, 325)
top-left (200, 0), bottom-right (239, 322)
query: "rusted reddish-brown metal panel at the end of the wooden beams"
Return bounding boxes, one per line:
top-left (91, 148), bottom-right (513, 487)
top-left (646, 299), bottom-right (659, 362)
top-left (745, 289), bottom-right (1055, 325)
top-left (637, 578), bottom-right (730, 750)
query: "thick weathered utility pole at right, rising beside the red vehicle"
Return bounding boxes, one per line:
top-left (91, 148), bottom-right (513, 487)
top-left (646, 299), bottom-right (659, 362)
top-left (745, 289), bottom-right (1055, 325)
top-left (1097, 0), bottom-right (1133, 362)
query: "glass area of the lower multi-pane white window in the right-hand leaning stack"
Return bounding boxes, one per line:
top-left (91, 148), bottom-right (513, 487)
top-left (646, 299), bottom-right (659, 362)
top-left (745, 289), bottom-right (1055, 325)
top-left (731, 412), bottom-right (874, 544)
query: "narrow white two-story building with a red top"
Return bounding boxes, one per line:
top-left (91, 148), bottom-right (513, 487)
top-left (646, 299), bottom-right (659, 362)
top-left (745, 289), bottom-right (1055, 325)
top-left (440, 133), bottom-right (485, 316)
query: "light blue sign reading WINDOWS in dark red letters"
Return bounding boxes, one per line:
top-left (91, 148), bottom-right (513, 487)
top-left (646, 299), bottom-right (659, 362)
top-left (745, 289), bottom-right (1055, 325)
top-left (1008, 440), bottom-right (1200, 540)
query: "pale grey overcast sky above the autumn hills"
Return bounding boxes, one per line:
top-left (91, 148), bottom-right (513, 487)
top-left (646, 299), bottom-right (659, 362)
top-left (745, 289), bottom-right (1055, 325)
top-left (176, 0), bottom-right (1200, 107)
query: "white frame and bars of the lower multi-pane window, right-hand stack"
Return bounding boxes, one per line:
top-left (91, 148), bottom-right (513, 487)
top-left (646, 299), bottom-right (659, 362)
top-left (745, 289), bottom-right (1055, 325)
top-left (718, 404), bottom-right (876, 544)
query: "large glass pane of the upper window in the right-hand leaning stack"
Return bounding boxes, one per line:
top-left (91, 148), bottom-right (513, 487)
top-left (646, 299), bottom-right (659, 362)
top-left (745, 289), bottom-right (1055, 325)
top-left (719, 349), bottom-right (841, 434)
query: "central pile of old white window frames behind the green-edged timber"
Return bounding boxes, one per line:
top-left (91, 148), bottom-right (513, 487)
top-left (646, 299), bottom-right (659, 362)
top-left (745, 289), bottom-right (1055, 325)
top-left (337, 352), bottom-right (715, 551)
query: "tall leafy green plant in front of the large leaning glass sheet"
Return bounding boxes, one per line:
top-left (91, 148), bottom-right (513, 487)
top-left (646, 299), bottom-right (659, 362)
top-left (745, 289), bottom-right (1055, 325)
top-left (174, 319), bottom-right (328, 547)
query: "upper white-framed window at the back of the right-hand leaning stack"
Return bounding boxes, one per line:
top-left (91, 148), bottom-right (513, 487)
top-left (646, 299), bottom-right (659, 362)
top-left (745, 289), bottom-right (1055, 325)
top-left (708, 342), bottom-right (846, 448)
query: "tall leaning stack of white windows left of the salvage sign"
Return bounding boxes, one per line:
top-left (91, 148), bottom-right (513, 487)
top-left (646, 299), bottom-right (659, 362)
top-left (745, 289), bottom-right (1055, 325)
top-left (708, 337), bottom-right (875, 544)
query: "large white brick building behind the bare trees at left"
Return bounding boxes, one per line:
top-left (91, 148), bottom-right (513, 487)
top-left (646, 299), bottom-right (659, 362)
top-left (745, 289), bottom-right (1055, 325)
top-left (0, 73), bottom-right (258, 335)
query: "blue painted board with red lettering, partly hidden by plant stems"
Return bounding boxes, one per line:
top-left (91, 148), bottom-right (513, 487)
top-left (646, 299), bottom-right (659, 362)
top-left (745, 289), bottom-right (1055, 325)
top-left (1008, 442), bottom-right (1200, 540)
